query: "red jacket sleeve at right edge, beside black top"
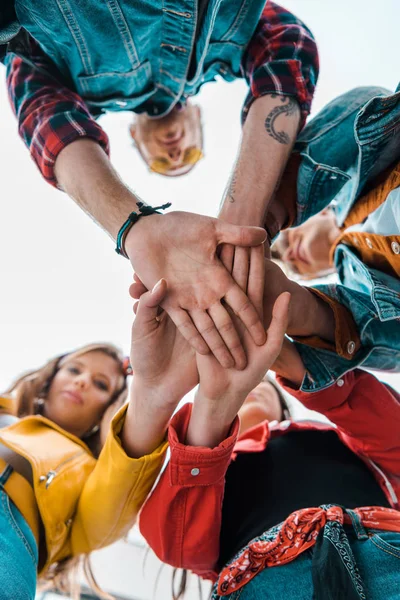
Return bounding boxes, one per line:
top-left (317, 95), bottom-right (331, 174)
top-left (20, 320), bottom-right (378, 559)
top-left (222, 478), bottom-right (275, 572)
top-left (277, 369), bottom-right (400, 475)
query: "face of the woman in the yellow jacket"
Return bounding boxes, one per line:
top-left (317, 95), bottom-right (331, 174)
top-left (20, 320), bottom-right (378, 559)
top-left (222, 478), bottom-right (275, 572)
top-left (43, 350), bottom-right (121, 438)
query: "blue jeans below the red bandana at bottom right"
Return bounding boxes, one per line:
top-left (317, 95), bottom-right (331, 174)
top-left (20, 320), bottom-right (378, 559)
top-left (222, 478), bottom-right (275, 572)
top-left (220, 528), bottom-right (400, 600)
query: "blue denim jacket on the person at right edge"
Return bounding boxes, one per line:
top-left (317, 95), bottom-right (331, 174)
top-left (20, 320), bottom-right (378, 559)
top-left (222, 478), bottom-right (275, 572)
top-left (294, 86), bottom-right (400, 392)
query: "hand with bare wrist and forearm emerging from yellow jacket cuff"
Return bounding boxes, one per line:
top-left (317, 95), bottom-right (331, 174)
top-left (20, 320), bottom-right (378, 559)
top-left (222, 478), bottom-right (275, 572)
top-left (121, 278), bottom-right (198, 458)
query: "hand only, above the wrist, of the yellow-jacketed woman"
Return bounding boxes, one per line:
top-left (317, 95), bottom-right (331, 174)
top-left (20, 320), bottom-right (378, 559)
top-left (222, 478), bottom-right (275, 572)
top-left (129, 276), bottom-right (198, 404)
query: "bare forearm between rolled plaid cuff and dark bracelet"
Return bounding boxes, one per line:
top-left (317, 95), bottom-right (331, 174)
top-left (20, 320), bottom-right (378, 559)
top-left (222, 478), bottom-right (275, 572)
top-left (54, 138), bottom-right (140, 239)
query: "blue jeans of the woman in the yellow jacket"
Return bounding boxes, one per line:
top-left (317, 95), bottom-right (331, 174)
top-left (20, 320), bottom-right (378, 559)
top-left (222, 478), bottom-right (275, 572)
top-left (0, 467), bottom-right (38, 600)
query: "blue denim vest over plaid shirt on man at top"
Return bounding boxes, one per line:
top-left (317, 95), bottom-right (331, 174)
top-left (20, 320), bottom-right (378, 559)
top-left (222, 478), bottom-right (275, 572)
top-left (16, 0), bottom-right (265, 116)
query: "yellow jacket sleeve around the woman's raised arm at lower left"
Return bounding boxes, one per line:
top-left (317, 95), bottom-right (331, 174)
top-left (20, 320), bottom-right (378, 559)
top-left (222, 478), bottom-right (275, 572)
top-left (71, 405), bottom-right (168, 555)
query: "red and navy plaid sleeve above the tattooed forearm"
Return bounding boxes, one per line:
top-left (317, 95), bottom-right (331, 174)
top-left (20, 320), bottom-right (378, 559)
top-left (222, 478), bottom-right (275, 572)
top-left (241, 1), bottom-right (319, 126)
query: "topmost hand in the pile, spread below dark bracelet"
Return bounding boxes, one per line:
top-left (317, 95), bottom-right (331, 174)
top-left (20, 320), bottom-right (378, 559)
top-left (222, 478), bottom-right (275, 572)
top-left (125, 212), bottom-right (265, 369)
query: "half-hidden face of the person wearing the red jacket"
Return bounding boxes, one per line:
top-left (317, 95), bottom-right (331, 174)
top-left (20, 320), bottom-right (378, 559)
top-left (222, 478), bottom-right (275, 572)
top-left (239, 381), bottom-right (283, 433)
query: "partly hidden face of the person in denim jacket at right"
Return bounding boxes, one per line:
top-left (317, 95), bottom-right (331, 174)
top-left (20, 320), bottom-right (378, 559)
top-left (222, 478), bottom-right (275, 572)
top-left (273, 209), bottom-right (340, 277)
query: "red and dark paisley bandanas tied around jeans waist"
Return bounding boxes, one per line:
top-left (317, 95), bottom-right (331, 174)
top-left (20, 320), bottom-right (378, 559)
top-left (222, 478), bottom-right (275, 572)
top-left (212, 504), bottom-right (400, 600)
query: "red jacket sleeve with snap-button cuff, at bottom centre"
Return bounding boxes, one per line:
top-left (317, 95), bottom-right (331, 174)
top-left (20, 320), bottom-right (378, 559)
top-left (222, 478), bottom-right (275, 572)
top-left (139, 404), bottom-right (238, 579)
